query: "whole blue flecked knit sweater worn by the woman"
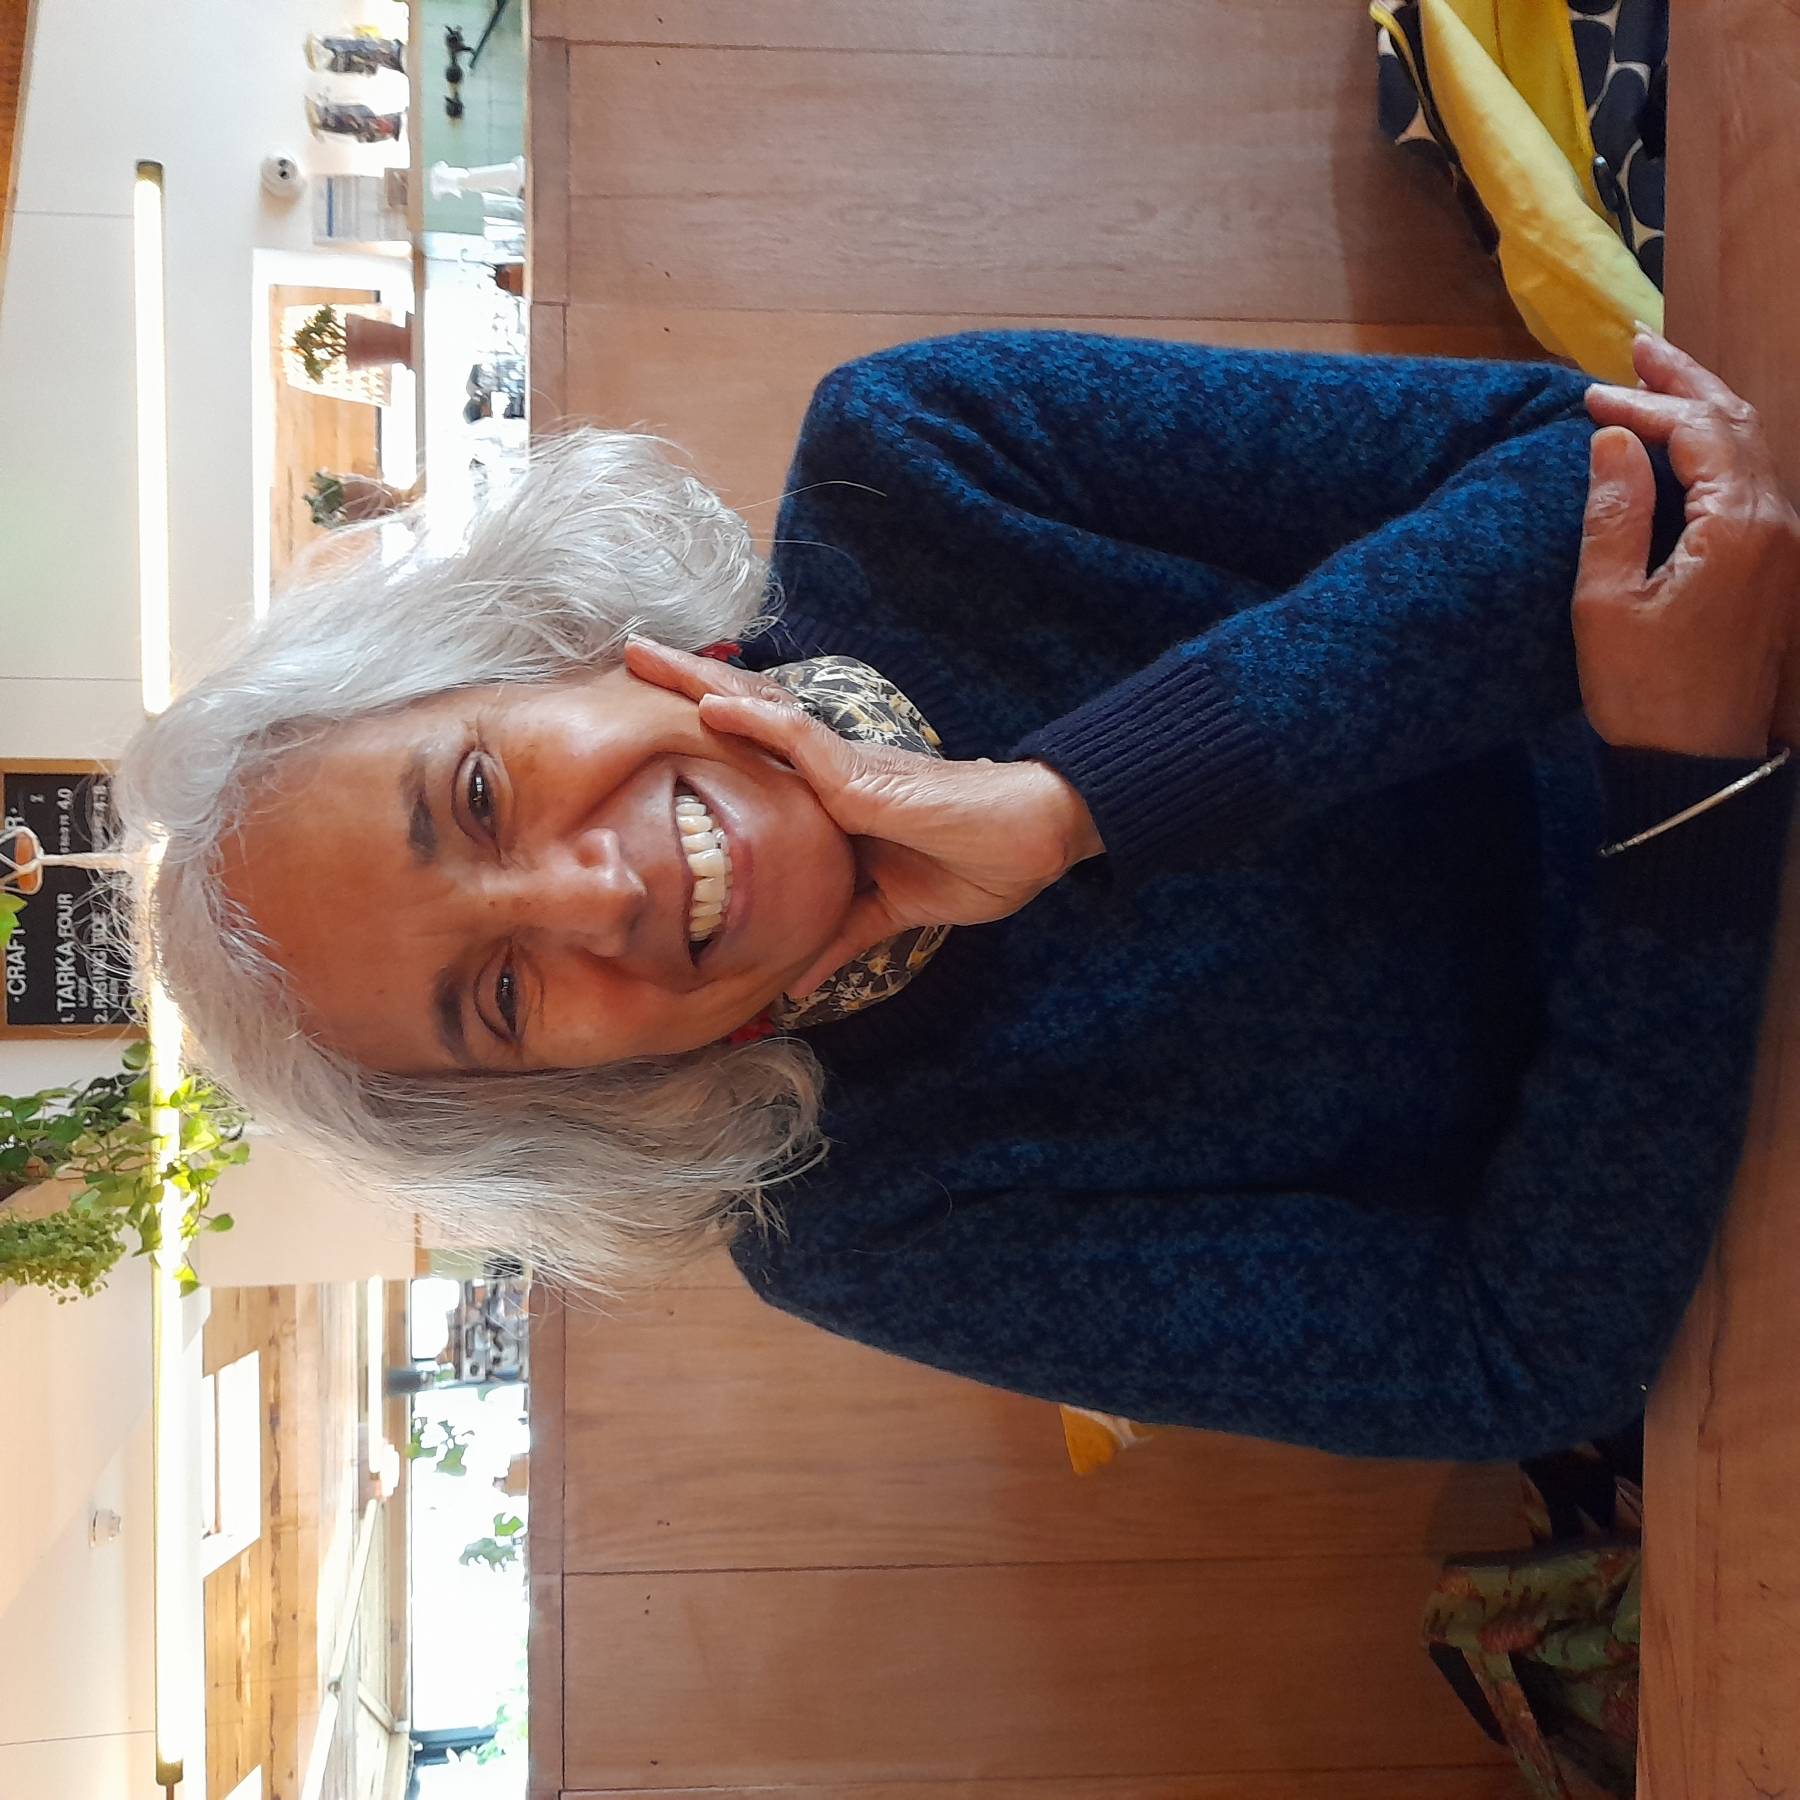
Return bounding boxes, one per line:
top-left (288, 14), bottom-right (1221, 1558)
top-left (734, 333), bottom-right (1791, 1458)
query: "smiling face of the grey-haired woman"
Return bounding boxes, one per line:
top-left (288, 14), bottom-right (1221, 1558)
top-left (225, 668), bottom-right (855, 1073)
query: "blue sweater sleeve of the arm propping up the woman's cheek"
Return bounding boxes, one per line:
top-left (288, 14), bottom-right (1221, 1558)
top-left (796, 333), bottom-right (1667, 880)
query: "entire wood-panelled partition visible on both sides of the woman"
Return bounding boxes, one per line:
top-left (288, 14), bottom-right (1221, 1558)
top-left (529, 0), bottom-right (1562, 1800)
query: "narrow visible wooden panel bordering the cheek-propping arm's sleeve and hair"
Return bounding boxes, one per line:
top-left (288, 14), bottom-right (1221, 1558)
top-left (565, 304), bottom-right (1537, 549)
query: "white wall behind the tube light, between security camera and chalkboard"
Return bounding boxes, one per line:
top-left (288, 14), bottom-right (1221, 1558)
top-left (0, 0), bottom-right (407, 1093)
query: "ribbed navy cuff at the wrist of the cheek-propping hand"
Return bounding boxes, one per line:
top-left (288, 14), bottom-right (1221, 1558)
top-left (1008, 650), bottom-right (1276, 880)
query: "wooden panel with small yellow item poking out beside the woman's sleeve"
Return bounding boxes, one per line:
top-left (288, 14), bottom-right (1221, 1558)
top-left (563, 1282), bottom-right (1517, 1576)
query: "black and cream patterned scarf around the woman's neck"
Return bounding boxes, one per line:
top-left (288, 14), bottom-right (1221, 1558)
top-left (763, 657), bottom-right (950, 1031)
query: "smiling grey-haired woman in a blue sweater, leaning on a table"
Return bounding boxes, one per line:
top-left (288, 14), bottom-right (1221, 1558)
top-left (122, 333), bottom-right (1800, 1456)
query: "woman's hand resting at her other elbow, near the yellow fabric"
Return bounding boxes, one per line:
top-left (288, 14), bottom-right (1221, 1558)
top-left (1575, 333), bottom-right (1800, 758)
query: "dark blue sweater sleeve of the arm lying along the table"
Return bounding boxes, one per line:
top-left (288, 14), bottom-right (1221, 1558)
top-left (738, 752), bottom-right (1795, 1460)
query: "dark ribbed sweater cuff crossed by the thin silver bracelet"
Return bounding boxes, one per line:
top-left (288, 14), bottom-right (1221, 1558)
top-left (1597, 745), bottom-right (1795, 940)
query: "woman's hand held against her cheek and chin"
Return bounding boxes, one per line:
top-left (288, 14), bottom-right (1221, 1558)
top-left (625, 639), bottom-right (1103, 997)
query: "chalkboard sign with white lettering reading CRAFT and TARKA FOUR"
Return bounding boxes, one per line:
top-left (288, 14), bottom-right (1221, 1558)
top-left (0, 758), bottom-right (140, 1037)
